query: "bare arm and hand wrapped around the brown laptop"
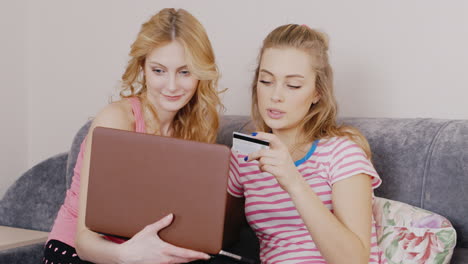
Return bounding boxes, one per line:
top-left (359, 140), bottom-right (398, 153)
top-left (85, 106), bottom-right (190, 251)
top-left (75, 103), bottom-right (209, 263)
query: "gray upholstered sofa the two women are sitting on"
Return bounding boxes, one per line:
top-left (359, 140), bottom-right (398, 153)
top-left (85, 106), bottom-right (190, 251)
top-left (0, 116), bottom-right (468, 263)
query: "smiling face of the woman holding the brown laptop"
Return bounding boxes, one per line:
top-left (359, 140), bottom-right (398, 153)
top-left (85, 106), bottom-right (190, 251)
top-left (144, 41), bottom-right (198, 117)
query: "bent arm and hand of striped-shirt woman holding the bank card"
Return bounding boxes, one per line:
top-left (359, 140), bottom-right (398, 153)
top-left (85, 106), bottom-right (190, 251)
top-left (248, 133), bottom-right (372, 264)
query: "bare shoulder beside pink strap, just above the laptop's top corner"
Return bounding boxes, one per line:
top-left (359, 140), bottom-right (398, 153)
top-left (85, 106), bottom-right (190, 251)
top-left (92, 99), bottom-right (135, 130)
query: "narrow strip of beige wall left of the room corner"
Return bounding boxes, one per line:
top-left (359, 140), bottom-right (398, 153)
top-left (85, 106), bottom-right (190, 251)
top-left (0, 1), bottom-right (28, 198)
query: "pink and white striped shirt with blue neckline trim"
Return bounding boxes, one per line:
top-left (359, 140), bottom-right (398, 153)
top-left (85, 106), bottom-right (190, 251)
top-left (228, 137), bottom-right (381, 264)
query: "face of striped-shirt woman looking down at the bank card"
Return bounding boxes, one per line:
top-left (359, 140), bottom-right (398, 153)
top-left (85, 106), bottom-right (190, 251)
top-left (257, 48), bottom-right (320, 132)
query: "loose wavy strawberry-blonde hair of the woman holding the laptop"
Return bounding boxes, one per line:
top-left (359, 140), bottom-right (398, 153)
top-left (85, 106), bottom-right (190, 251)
top-left (120, 8), bottom-right (222, 143)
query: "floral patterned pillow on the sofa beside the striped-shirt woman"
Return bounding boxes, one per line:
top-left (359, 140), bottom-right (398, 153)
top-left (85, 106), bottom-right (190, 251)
top-left (373, 197), bottom-right (457, 264)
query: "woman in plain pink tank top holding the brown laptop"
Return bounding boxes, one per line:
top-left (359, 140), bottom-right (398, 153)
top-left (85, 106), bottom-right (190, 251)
top-left (43, 9), bottom-right (221, 264)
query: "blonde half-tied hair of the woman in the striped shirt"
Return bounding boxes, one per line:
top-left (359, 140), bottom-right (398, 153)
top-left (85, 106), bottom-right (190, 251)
top-left (252, 24), bottom-right (371, 159)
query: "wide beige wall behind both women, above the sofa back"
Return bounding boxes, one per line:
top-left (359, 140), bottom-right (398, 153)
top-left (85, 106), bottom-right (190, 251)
top-left (0, 0), bottom-right (468, 196)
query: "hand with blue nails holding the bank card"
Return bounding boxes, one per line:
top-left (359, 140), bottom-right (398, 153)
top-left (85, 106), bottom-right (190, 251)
top-left (245, 132), bottom-right (304, 192)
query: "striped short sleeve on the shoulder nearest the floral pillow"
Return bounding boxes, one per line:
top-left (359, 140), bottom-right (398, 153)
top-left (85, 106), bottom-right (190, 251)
top-left (329, 138), bottom-right (382, 189)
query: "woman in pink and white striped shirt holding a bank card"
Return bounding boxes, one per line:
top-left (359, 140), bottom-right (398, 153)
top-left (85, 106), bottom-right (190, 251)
top-left (229, 24), bottom-right (381, 264)
